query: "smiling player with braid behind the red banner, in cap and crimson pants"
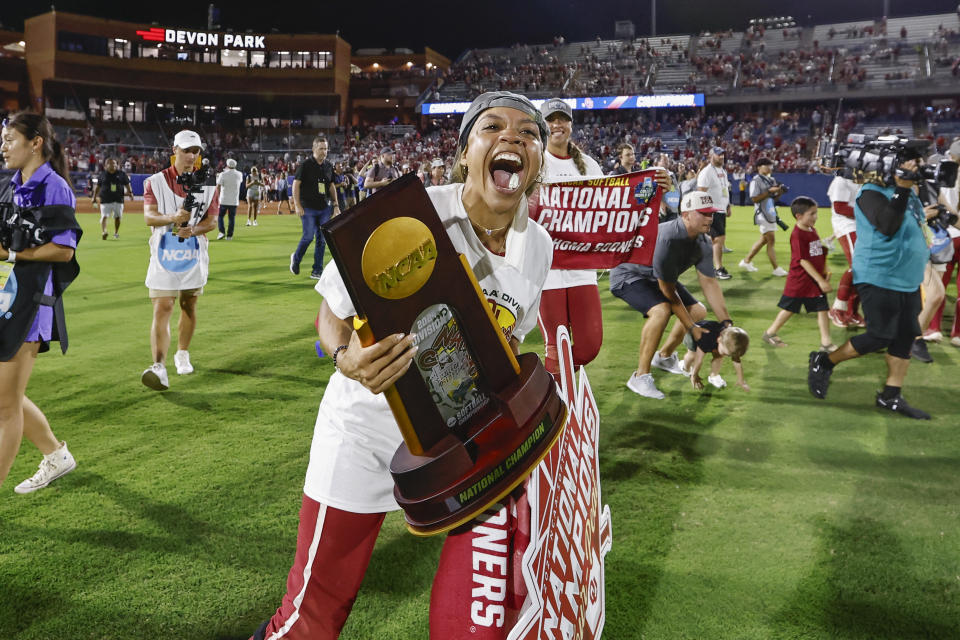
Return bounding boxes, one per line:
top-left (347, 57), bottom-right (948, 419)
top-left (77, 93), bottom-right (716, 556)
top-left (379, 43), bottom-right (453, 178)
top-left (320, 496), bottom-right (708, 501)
top-left (537, 98), bottom-right (604, 373)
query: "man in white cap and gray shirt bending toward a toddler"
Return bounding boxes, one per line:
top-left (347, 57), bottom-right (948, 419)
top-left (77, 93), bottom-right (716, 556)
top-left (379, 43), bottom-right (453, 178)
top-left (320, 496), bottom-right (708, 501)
top-left (610, 191), bottom-right (733, 400)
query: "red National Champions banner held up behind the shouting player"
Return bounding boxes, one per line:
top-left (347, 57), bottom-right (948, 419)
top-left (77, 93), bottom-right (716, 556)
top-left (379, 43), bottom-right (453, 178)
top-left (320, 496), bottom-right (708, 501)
top-left (530, 169), bottom-right (663, 269)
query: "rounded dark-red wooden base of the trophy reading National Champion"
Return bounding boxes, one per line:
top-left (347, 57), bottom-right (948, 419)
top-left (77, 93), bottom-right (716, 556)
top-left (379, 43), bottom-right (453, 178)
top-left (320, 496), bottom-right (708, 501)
top-left (390, 353), bottom-right (567, 536)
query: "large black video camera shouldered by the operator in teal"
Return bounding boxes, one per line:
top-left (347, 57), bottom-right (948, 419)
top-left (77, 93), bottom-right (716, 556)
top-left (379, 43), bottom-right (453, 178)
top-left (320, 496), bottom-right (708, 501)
top-left (816, 133), bottom-right (957, 193)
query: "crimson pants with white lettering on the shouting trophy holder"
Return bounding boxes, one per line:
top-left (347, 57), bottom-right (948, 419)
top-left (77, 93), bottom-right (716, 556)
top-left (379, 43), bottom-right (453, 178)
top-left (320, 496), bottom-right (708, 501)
top-left (251, 496), bottom-right (530, 640)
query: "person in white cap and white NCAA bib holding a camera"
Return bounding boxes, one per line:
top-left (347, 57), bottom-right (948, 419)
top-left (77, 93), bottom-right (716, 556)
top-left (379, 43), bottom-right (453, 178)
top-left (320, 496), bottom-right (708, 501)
top-left (140, 130), bottom-right (219, 391)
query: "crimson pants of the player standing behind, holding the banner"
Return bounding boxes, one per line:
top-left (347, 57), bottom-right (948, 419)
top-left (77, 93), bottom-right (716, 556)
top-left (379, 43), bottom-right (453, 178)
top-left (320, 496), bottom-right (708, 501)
top-left (537, 284), bottom-right (603, 373)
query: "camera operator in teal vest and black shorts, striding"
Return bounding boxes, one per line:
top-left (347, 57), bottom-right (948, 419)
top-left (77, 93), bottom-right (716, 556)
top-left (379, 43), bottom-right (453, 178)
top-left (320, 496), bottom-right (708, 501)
top-left (807, 144), bottom-right (936, 420)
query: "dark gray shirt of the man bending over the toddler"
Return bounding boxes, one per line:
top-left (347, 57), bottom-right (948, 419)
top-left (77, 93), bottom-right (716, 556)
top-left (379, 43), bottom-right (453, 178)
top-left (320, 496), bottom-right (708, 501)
top-left (610, 218), bottom-right (717, 290)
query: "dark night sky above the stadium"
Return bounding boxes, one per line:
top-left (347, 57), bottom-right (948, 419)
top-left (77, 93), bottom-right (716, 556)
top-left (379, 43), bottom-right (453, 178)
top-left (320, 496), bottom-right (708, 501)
top-left (0, 0), bottom-right (956, 58)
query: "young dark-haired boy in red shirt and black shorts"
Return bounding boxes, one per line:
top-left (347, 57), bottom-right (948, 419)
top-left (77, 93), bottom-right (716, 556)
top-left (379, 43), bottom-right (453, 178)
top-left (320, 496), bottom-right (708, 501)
top-left (760, 196), bottom-right (837, 351)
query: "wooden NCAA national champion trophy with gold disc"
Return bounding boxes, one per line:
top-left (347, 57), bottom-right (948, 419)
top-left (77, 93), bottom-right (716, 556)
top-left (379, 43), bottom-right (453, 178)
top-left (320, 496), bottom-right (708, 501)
top-left (323, 174), bottom-right (567, 536)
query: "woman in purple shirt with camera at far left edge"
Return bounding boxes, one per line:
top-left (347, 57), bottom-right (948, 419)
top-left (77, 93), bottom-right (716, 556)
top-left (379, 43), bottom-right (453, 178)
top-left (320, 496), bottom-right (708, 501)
top-left (0, 112), bottom-right (82, 493)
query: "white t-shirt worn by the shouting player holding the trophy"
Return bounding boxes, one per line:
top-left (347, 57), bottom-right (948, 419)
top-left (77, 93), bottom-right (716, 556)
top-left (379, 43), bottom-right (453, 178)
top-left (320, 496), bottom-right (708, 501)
top-left (303, 184), bottom-right (553, 513)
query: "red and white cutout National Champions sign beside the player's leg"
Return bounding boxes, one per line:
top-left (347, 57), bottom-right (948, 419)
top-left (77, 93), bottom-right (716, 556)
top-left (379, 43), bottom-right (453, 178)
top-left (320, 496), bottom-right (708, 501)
top-left (507, 326), bottom-right (613, 640)
